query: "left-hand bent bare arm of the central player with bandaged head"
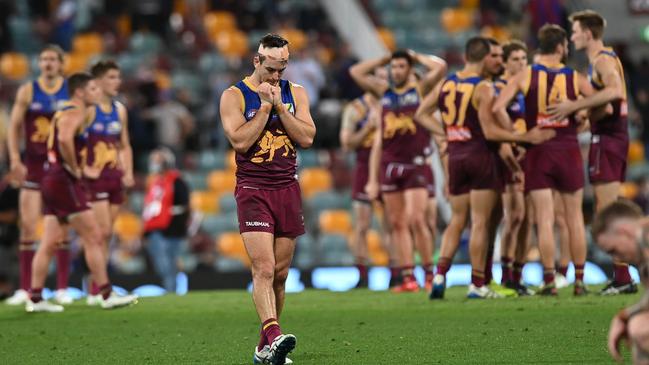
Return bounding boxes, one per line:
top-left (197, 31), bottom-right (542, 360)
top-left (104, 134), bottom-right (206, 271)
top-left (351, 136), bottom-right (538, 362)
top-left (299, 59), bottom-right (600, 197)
top-left (220, 87), bottom-right (273, 153)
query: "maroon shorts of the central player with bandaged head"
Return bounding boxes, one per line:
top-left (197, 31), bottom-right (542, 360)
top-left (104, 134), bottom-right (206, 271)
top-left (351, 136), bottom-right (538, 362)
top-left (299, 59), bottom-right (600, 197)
top-left (234, 181), bottom-right (304, 238)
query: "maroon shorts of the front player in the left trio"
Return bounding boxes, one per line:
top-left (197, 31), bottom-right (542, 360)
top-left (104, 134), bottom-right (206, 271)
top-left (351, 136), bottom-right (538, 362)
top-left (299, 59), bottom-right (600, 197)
top-left (41, 167), bottom-right (90, 221)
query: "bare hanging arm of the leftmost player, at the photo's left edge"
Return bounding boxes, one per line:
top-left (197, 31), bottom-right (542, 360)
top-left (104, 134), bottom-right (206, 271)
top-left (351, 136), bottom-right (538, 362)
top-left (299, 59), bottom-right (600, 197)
top-left (7, 84), bottom-right (32, 181)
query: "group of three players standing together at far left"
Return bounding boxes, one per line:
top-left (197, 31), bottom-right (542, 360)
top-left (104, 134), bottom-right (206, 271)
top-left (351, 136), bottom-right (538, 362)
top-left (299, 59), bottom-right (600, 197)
top-left (7, 45), bottom-right (137, 312)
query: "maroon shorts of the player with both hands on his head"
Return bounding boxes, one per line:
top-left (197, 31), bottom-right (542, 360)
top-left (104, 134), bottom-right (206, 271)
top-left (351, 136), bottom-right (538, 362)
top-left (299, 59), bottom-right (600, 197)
top-left (379, 162), bottom-right (430, 193)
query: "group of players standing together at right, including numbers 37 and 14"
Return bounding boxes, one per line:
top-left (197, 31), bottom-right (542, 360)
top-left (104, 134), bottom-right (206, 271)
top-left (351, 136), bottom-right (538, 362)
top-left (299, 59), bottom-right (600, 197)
top-left (341, 10), bottom-right (637, 299)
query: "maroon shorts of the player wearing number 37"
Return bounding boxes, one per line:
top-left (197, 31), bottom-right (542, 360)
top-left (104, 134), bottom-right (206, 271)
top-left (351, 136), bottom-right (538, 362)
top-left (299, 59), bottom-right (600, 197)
top-left (448, 151), bottom-right (504, 195)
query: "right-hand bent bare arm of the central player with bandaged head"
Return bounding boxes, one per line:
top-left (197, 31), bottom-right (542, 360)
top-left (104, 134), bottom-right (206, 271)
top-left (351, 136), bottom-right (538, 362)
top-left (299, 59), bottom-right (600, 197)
top-left (274, 84), bottom-right (315, 148)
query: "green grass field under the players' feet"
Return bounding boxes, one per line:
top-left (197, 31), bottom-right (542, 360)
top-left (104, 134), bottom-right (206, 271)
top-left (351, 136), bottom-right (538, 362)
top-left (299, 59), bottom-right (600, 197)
top-left (0, 288), bottom-right (638, 365)
